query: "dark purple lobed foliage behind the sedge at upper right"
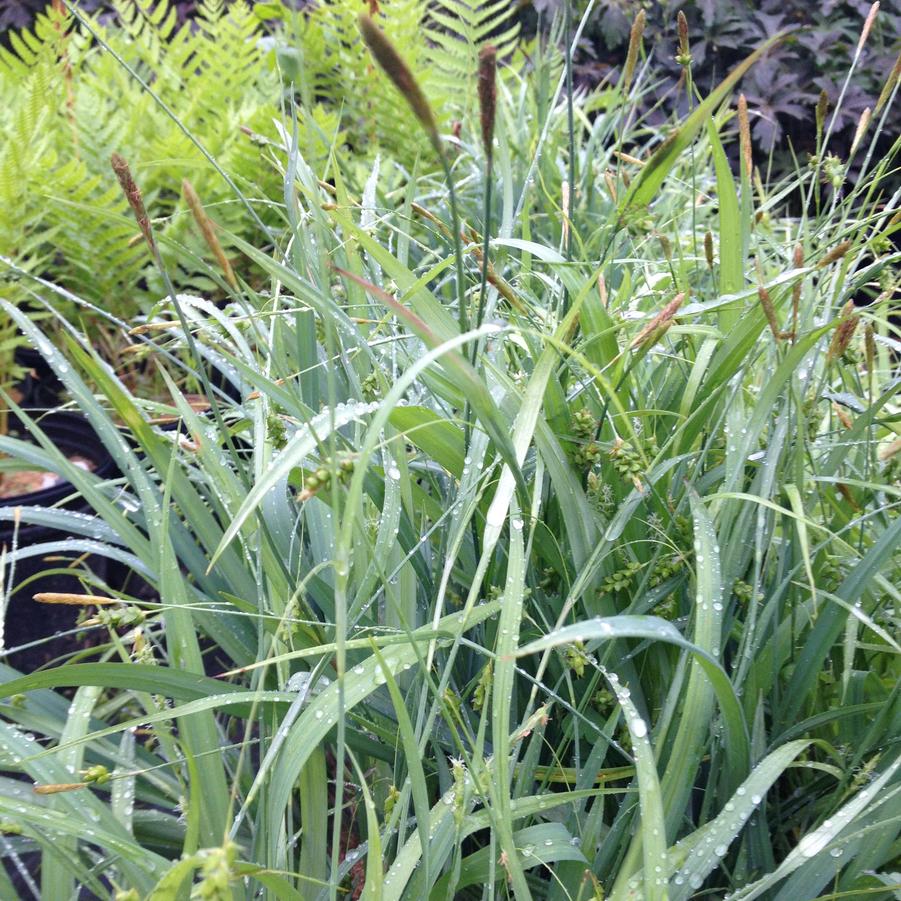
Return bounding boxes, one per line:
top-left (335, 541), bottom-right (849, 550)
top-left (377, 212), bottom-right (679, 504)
top-left (532, 0), bottom-right (901, 169)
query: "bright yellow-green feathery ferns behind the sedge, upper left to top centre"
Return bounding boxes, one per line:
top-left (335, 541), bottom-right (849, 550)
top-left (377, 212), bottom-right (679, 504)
top-left (0, 0), bottom-right (518, 319)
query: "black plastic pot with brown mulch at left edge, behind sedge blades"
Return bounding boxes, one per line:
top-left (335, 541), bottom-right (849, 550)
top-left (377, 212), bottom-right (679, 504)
top-left (0, 413), bottom-right (116, 672)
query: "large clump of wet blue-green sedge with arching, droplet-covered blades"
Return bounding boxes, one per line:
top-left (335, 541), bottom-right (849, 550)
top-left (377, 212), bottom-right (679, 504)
top-left (0, 2), bottom-right (901, 901)
